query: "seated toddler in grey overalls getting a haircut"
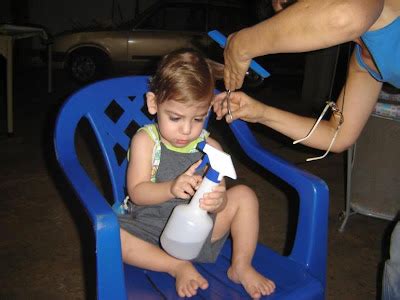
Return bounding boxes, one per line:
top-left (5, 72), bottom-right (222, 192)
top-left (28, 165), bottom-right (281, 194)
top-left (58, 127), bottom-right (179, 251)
top-left (119, 49), bottom-right (275, 298)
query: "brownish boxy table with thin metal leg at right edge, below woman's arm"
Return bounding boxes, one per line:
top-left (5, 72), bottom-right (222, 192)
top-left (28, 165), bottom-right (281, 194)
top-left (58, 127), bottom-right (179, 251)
top-left (339, 114), bottom-right (400, 232)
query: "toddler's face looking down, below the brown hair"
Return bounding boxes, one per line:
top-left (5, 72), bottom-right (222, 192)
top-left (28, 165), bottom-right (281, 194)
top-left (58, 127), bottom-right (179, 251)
top-left (157, 100), bottom-right (210, 148)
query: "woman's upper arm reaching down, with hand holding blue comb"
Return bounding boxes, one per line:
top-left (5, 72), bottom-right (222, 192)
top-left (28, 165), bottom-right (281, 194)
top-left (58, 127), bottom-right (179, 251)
top-left (224, 0), bottom-right (384, 90)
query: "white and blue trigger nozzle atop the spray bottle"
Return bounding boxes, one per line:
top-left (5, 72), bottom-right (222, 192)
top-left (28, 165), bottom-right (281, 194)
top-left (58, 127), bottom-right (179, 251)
top-left (196, 141), bottom-right (236, 182)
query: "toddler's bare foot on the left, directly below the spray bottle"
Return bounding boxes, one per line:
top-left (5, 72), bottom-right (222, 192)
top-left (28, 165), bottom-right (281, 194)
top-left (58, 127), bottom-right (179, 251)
top-left (171, 261), bottom-right (208, 297)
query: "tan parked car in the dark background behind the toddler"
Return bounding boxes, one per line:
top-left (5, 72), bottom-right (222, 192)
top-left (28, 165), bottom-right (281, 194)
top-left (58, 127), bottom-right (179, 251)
top-left (53, 0), bottom-right (262, 85)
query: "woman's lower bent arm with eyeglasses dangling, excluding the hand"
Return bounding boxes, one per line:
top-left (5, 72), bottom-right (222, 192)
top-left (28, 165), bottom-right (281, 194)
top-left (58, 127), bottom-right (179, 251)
top-left (258, 54), bottom-right (382, 152)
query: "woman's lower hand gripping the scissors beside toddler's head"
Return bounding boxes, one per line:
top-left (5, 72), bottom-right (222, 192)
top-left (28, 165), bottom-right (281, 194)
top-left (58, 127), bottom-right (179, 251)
top-left (213, 92), bottom-right (266, 123)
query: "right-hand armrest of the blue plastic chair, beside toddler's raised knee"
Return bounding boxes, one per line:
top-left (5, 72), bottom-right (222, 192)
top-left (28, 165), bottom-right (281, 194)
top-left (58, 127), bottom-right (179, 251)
top-left (230, 120), bottom-right (329, 285)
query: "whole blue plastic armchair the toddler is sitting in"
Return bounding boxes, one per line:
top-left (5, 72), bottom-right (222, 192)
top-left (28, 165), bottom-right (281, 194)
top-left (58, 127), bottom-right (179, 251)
top-left (55, 76), bottom-right (328, 300)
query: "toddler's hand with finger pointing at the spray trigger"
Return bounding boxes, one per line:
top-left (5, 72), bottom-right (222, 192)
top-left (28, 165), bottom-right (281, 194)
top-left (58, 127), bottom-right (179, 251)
top-left (171, 160), bottom-right (202, 199)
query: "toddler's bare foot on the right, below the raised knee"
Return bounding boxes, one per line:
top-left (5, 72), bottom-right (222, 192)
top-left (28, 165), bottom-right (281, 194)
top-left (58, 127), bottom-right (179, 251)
top-left (228, 264), bottom-right (275, 299)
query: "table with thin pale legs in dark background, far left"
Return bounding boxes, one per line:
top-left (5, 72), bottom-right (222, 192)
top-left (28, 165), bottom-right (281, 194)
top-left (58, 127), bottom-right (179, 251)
top-left (0, 24), bottom-right (52, 135)
